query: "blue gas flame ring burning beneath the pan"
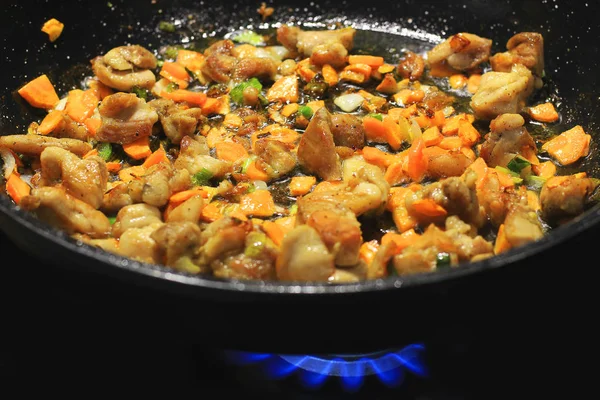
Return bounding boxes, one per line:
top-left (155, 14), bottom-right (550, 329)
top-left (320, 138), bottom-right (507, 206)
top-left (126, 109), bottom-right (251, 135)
top-left (226, 344), bottom-right (428, 392)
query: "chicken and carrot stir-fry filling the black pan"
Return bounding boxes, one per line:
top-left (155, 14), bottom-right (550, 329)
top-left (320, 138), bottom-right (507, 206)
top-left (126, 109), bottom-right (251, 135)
top-left (0, 24), bottom-right (598, 283)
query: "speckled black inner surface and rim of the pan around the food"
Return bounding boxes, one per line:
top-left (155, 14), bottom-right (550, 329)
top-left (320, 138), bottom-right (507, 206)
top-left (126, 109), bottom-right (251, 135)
top-left (0, 1), bottom-right (600, 294)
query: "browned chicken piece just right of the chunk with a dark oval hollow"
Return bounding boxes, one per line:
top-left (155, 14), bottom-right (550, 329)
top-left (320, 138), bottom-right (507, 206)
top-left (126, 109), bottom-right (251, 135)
top-left (148, 99), bottom-right (206, 144)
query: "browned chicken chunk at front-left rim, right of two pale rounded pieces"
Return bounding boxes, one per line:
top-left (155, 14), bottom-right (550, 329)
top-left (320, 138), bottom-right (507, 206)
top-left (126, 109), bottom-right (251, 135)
top-left (150, 221), bottom-right (207, 273)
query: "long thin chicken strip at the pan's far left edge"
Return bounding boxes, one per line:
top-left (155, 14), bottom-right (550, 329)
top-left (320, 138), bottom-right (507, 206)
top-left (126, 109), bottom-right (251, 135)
top-left (0, 135), bottom-right (92, 157)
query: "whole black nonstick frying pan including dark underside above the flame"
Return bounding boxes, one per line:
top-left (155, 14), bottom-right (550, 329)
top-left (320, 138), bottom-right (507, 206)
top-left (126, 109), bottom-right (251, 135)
top-left (0, 0), bottom-right (600, 352)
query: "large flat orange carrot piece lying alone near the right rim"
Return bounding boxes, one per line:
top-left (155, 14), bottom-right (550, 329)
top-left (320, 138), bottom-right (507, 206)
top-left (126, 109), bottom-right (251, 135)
top-left (542, 125), bottom-right (592, 165)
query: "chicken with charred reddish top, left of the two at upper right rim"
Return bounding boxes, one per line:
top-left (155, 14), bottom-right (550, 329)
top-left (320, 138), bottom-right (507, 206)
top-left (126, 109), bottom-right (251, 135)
top-left (427, 32), bottom-right (492, 71)
